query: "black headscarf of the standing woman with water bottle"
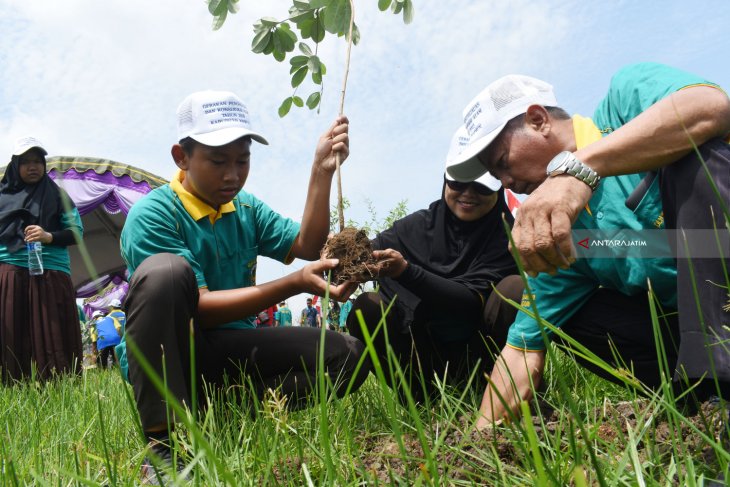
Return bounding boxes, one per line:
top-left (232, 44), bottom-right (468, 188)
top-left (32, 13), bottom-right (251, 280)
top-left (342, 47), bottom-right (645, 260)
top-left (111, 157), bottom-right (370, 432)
top-left (0, 156), bottom-right (68, 253)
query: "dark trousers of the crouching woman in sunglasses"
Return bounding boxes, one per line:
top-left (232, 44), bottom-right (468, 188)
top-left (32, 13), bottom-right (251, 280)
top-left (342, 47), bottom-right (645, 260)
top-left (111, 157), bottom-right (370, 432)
top-left (347, 276), bottom-right (523, 402)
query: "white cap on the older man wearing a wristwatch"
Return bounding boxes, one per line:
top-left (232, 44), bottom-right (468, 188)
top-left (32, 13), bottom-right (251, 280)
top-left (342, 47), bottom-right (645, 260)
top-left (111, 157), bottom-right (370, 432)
top-left (448, 74), bottom-right (558, 181)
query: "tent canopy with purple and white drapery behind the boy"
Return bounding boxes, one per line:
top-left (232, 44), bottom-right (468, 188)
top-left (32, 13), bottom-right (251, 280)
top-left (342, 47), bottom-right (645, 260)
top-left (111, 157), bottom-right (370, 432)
top-left (46, 157), bottom-right (167, 292)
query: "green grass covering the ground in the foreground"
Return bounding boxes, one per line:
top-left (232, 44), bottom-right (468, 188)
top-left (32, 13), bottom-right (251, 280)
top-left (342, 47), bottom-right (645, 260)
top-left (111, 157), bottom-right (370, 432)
top-left (0, 342), bottom-right (729, 486)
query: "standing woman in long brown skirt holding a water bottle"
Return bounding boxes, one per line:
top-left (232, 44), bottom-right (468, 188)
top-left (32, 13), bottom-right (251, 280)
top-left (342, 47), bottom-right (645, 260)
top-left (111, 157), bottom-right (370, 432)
top-left (0, 137), bottom-right (82, 381)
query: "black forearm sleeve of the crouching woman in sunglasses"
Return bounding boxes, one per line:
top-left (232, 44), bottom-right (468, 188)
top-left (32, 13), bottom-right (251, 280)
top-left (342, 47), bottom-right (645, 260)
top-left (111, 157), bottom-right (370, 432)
top-left (396, 263), bottom-right (483, 312)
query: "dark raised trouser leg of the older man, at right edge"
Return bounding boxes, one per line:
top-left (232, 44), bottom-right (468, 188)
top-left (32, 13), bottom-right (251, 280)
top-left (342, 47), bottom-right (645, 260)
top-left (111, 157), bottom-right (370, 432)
top-left (659, 139), bottom-right (730, 387)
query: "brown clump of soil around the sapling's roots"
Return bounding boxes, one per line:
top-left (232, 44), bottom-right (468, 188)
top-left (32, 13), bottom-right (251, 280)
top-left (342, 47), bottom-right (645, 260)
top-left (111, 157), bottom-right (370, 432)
top-left (321, 227), bottom-right (377, 285)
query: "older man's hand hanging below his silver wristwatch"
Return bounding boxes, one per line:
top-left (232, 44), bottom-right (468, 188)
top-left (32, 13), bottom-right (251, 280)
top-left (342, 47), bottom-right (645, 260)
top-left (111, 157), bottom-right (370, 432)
top-left (512, 175), bottom-right (593, 277)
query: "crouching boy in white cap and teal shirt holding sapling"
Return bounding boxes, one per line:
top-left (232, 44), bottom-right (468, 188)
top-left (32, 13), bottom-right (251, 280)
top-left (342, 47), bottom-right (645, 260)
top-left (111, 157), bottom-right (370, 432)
top-left (117, 91), bottom-right (368, 474)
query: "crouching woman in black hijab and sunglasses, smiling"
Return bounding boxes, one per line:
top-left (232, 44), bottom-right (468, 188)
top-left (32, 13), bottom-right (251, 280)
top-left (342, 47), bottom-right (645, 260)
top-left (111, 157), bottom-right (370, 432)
top-left (347, 155), bottom-right (522, 401)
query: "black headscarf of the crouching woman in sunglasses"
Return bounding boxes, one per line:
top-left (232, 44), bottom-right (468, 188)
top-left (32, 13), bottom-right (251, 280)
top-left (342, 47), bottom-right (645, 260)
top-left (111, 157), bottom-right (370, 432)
top-left (373, 184), bottom-right (517, 330)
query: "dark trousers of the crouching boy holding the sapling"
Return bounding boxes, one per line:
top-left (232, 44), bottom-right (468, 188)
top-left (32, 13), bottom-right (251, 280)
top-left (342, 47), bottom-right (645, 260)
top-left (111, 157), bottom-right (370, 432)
top-left (125, 254), bottom-right (369, 431)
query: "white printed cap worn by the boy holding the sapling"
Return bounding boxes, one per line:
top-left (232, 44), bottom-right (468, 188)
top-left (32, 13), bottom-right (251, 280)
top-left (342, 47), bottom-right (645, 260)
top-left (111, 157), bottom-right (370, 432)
top-left (177, 90), bottom-right (269, 147)
